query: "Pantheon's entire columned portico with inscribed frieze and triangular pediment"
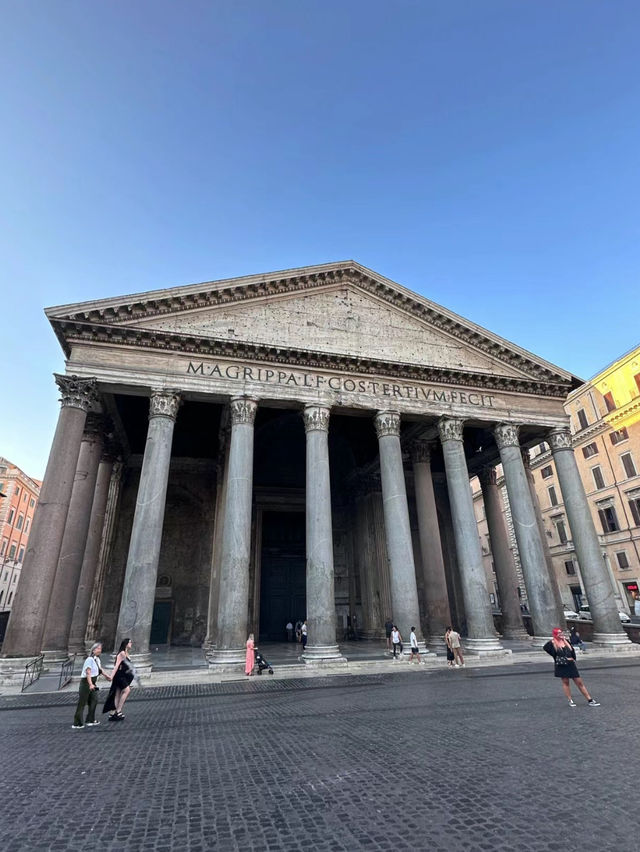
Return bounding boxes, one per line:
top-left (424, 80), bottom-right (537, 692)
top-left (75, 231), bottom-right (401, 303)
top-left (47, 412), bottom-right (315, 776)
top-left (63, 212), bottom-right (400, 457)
top-left (0, 261), bottom-right (630, 680)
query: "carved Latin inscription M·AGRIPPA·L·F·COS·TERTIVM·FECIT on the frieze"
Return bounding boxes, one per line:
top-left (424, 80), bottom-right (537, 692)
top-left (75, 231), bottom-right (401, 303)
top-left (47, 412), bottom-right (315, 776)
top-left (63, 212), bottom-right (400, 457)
top-left (187, 361), bottom-right (494, 408)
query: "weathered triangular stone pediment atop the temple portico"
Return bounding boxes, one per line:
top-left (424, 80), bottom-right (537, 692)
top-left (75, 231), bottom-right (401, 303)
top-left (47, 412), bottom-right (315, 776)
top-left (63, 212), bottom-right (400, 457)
top-left (47, 261), bottom-right (575, 385)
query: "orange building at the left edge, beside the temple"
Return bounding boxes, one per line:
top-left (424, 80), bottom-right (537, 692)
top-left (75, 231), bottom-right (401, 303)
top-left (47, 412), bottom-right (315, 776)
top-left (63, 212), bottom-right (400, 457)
top-left (0, 456), bottom-right (42, 624)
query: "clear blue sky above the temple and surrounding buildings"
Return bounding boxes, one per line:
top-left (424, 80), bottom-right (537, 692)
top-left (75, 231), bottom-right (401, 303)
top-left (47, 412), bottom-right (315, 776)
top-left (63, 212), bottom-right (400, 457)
top-left (0, 0), bottom-right (640, 477)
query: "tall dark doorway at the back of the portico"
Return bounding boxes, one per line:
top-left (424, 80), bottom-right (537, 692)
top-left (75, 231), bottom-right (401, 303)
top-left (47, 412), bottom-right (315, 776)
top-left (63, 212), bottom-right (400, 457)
top-left (260, 511), bottom-right (307, 642)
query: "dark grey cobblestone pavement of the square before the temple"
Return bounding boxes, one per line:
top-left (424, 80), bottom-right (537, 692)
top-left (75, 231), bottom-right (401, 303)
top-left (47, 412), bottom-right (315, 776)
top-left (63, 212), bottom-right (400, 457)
top-left (0, 661), bottom-right (640, 852)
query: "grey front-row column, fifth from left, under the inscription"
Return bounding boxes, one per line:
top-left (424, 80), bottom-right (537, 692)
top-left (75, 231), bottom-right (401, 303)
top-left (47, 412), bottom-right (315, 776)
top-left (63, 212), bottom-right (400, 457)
top-left (374, 411), bottom-right (427, 653)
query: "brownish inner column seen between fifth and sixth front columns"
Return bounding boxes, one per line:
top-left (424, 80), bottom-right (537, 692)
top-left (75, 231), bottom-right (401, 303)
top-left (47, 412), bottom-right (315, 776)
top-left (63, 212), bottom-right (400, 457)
top-left (411, 441), bottom-right (451, 650)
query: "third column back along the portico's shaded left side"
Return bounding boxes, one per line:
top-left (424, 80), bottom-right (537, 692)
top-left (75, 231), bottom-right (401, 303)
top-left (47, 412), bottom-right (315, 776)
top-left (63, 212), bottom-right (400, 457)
top-left (69, 449), bottom-right (115, 654)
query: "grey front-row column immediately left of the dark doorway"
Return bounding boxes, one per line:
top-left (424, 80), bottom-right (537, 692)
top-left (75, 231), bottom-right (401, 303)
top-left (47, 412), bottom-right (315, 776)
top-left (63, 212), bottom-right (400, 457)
top-left (209, 396), bottom-right (258, 671)
